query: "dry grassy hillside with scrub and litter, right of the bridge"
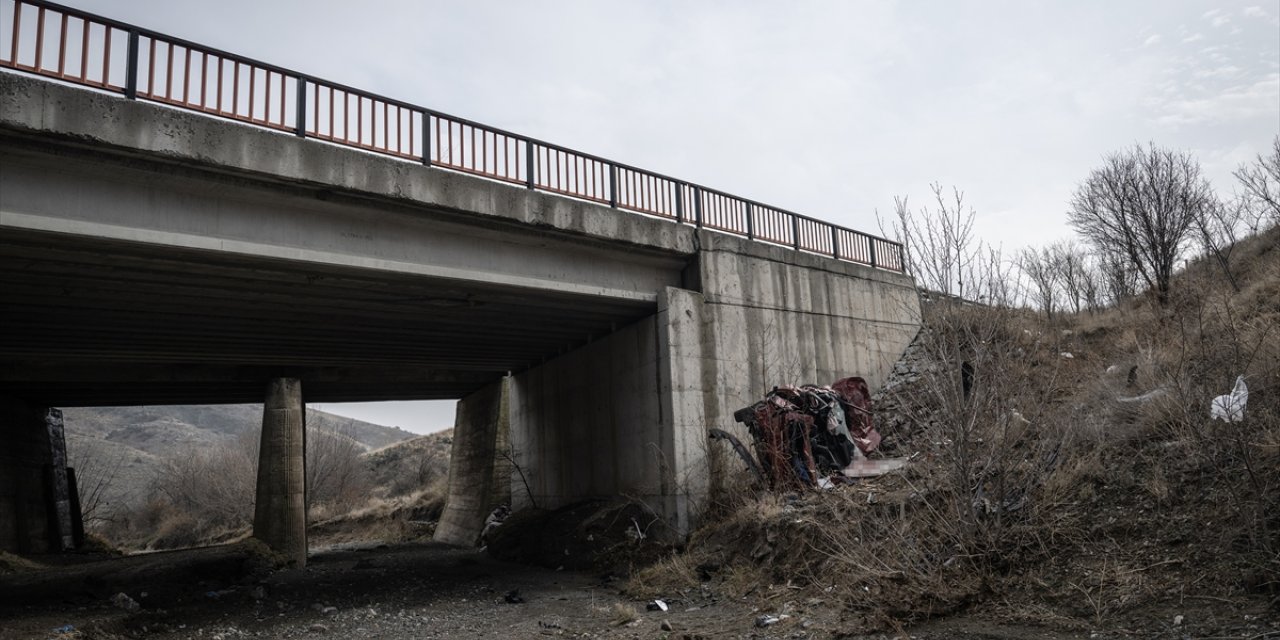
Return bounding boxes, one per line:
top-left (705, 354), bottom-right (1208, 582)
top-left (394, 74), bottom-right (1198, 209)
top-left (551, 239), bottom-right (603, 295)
top-left (630, 228), bottom-right (1280, 637)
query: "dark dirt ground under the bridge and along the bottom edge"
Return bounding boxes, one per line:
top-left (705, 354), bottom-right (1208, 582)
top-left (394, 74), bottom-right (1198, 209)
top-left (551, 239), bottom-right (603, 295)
top-left (0, 543), bottom-right (1280, 640)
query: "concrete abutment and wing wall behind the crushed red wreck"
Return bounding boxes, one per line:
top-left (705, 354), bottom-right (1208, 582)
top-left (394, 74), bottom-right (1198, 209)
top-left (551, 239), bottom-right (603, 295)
top-left (501, 238), bottom-right (920, 532)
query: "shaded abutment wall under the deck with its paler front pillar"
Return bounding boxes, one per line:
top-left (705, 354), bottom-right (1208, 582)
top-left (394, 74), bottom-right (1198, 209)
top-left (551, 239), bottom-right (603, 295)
top-left (511, 287), bottom-right (708, 535)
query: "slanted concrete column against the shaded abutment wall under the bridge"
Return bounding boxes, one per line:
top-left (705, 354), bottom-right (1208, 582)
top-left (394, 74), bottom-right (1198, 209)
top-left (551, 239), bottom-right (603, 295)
top-left (434, 379), bottom-right (511, 547)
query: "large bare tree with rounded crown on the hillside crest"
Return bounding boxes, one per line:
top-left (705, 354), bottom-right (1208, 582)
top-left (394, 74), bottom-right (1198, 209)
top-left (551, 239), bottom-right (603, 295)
top-left (1068, 143), bottom-right (1213, 305)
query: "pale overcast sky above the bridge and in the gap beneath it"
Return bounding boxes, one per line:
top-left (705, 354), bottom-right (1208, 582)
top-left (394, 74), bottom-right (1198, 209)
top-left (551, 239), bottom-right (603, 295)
top-left (67, 0), bottom-right (1280, 431)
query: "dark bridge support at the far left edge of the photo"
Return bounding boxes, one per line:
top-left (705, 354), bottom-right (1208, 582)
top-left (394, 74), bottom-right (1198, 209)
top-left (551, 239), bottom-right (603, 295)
top-left (0, 398), bottom-right (79, 553)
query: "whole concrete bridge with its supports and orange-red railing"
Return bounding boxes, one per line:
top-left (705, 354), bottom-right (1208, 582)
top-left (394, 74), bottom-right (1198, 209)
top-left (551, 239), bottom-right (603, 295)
top-left (0, 1), bottom-right (919, 564)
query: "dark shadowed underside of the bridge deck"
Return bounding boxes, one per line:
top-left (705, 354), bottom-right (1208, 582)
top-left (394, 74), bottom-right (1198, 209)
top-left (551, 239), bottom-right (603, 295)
top-left (0, 228), bottom-right (654, 406)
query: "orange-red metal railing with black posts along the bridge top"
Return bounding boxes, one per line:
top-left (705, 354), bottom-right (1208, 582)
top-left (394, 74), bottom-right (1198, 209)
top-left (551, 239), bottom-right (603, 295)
top-left (0, 0), bottom-right (904, 271)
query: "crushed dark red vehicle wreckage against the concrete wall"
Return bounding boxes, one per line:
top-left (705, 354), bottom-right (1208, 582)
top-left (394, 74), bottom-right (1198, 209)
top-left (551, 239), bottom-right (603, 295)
top-left (721, 378), bottom-right (906, 489)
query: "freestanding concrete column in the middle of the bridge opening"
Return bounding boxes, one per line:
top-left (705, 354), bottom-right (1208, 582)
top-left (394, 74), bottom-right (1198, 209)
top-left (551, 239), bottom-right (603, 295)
top-left (253, 378), bottom-right (307, 568)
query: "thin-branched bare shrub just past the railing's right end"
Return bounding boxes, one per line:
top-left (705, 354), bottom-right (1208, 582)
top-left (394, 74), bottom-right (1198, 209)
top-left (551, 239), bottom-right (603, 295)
top-left (881, 183), bottom-right (982, 298)
